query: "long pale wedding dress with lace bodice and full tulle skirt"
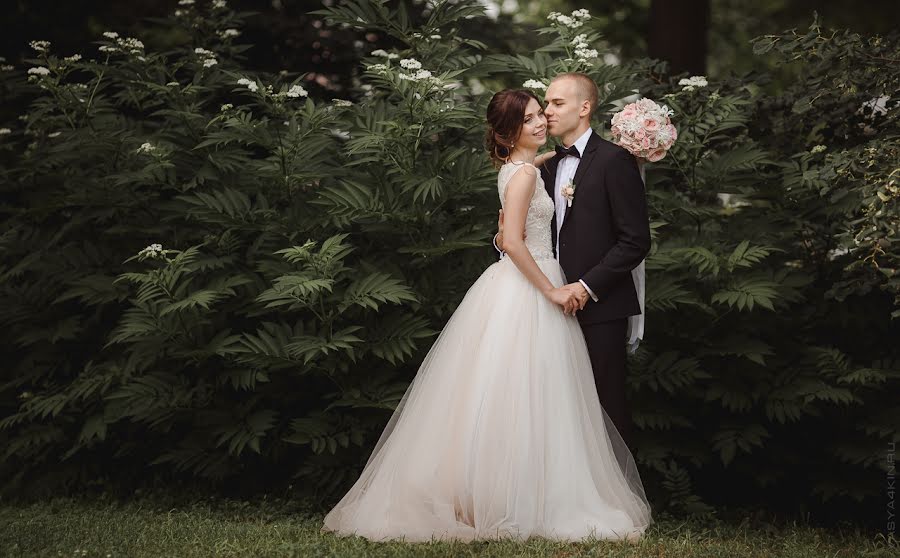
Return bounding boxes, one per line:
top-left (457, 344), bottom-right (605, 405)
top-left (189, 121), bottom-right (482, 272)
top-left (323, 163), bottom-right (652, 541)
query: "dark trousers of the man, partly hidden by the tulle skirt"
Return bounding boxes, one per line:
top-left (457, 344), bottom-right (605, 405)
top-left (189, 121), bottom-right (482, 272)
top-left (581, 318), bottom-right (632, 449)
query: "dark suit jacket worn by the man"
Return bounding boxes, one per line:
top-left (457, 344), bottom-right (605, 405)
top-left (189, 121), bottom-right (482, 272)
top-left (541, 132), bottom-right (650, 324)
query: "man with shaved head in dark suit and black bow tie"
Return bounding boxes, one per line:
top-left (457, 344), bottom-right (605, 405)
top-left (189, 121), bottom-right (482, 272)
top-left (497, 73), bottom-right (650, 446)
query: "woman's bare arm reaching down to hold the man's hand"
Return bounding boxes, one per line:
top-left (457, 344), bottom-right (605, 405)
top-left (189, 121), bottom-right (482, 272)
top-left (503, 165), bottom-right (578, 314)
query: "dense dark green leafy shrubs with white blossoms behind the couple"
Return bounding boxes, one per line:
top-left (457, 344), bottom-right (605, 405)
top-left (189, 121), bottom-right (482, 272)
top-left (0, 1), bottom-right (900, 526)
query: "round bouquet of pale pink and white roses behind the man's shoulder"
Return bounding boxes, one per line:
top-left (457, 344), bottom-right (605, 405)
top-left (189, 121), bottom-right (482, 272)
top-left (612, 99), bottom-right (678, 162)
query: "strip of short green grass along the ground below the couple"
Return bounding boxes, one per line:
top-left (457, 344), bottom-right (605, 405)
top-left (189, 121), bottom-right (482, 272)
top-left (0, 497), bottom-right (900, 558)
